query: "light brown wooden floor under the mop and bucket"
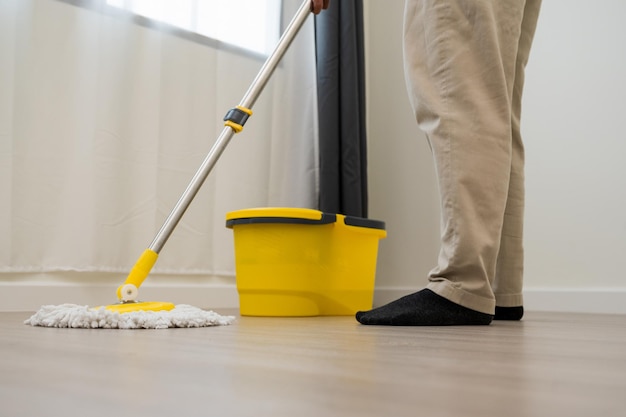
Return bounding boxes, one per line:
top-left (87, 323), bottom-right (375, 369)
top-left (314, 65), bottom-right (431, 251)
top-left (0, 311), bottom-right (626, 417)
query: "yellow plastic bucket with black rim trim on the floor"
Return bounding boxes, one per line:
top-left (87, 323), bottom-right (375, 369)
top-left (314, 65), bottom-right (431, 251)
top-left (226, 208), bottom-right (386, 317)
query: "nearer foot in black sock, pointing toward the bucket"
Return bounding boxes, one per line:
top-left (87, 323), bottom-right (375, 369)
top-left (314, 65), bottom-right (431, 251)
top-left (356, 288), bottom-right (493, 326)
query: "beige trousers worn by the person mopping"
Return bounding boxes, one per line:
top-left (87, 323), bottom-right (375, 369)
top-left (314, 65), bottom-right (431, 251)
top-left (404, 0), bottom-right (541, 314)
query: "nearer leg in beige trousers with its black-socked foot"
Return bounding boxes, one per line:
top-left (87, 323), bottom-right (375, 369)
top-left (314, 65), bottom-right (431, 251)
top-left (357, 0), bottom-right (524, 325)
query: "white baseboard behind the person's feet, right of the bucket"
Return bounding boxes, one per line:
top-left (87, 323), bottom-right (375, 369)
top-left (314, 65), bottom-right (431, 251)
top-left (374, 288), bottom-right (626, 314)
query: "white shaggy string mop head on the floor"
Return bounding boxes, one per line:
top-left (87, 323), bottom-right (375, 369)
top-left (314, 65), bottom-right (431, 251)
top-left (24, 304), bottom-right (235, 329)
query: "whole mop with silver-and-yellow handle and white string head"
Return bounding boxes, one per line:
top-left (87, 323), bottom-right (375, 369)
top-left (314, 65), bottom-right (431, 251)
top-left (24, 0), bottom-right (311, 329)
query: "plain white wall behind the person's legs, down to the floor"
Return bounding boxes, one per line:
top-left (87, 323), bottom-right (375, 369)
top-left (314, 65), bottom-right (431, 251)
top-left (365, 0), bottom-right (626, 313)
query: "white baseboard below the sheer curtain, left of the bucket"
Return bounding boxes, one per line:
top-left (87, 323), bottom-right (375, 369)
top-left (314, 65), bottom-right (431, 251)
top-left (0, 282), bottom-right (239, 312)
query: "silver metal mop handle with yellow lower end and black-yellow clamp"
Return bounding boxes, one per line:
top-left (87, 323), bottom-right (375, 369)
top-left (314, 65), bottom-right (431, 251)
top-left (117, 0), bottom-right (311, 299)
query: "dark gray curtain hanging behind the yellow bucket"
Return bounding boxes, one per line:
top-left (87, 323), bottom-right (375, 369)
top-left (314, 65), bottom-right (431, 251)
top-left (315, 0), bottom-right (367, 217)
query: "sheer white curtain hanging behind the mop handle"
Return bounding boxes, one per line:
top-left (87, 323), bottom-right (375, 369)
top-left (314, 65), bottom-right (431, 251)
top-left (0, 0), bottom-right (317, 281)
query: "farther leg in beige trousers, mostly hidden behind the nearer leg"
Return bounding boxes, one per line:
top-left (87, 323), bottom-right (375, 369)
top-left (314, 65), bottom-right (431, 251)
top-left (493, 0), bottom-right (541, 320)
